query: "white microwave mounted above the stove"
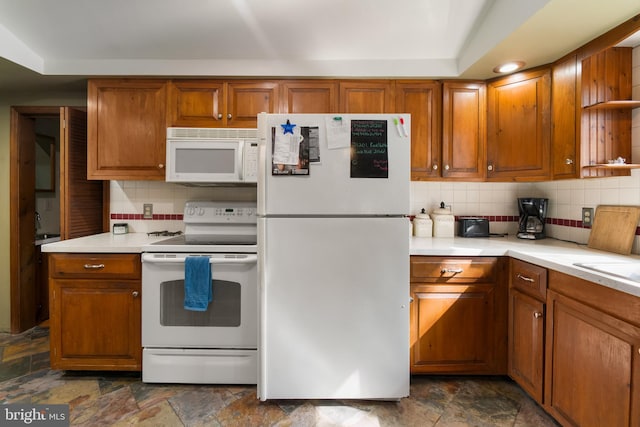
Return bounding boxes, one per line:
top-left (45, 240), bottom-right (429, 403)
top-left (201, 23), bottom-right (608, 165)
top-left (165, 127), bottom-right (258, 185)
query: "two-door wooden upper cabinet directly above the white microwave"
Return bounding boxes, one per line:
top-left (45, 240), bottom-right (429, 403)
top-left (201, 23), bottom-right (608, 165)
top-left (167, 80), bottom-right (279, 128)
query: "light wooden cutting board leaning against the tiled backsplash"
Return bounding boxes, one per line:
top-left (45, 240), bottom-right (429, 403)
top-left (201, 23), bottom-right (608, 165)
top-left (588, 205), bottom-right (640, 255)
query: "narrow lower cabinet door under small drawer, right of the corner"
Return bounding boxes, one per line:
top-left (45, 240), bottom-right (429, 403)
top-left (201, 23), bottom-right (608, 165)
top-left (508, 289), bottom-right (544, 404)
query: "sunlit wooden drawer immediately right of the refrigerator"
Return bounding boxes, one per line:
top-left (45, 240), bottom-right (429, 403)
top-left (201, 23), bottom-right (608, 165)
top-left (411, 256), bottom-right (500, 283)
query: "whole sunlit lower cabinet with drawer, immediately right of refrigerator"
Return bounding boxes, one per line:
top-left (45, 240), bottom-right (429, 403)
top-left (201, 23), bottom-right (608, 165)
top-left (410, 256), bottom-right (507, 374)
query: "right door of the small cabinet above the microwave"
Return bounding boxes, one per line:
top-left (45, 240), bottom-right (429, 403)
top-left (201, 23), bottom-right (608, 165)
top-left (226, 80), bottom-right (278, 128)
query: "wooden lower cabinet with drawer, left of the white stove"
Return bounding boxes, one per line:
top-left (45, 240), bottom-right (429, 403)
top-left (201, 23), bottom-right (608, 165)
top-left (49, 254), bottom-right (142, 371)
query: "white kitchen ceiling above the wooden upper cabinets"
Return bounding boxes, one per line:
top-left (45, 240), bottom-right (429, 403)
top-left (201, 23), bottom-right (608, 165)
top-left (0, 0), bottom-right (640, 93)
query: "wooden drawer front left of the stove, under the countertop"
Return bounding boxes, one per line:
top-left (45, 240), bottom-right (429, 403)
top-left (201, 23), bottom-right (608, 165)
top-left (49, 253), bottom-right (142, 279)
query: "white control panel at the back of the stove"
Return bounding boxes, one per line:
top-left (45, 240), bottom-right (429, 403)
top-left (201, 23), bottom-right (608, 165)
top-left (183, 201), bottom-right (257, 224)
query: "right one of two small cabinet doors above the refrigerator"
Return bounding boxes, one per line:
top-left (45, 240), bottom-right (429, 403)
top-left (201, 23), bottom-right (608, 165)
top-left (339, 80), bottom-right (394, 114)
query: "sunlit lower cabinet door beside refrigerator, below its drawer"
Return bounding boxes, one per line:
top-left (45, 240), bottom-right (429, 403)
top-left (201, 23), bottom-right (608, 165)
top-left (410, 284), bottom-right (506, 374)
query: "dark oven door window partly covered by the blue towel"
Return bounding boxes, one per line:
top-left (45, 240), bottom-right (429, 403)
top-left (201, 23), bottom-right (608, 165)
top-left (160, 279), bottom-right (241, 327)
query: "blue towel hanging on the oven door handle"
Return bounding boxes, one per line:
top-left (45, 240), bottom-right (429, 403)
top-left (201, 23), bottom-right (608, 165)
top-left (184, 256), bottom-right (213, 311)
